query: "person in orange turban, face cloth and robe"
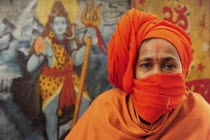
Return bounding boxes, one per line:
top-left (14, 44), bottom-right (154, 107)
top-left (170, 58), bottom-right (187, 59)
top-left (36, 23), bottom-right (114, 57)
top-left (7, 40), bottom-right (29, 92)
top-left (65, 9), bottom-right (210, 140)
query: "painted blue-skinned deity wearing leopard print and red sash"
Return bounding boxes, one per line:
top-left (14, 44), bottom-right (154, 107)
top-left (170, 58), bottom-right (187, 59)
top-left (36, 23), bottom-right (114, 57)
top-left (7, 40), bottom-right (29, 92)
top-left (27, 1), bottom-right (90, 140)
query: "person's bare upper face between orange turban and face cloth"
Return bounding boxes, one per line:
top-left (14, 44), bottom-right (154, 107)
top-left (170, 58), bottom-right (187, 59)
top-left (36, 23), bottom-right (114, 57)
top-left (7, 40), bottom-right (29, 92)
top-left (134, 38), bottom-right (182, 79)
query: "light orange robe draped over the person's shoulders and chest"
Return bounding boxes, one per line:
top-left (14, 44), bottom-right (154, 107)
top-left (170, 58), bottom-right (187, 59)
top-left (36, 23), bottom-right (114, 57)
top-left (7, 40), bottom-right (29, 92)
top-left (65, 89), bottom-right (210, 140)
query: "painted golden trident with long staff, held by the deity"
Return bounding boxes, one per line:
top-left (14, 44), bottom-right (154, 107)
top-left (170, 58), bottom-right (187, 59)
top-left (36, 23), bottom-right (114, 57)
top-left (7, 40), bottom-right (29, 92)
top-left (72, 2), bottom-right (101, 128)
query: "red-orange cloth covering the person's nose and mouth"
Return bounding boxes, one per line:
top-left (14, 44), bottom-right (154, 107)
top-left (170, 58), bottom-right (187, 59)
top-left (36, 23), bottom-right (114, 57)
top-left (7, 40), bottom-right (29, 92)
top-left (132, 73), bottom-right (186, 123)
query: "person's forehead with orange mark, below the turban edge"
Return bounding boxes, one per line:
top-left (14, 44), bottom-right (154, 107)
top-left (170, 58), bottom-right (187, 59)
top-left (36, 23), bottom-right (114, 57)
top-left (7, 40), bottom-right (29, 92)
top-left (138, 38), bottom-right (179, 58)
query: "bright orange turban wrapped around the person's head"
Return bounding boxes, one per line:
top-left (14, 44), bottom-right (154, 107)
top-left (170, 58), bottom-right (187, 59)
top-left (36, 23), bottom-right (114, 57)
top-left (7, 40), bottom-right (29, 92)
top-left (108, 9), bottom-right (192, 94)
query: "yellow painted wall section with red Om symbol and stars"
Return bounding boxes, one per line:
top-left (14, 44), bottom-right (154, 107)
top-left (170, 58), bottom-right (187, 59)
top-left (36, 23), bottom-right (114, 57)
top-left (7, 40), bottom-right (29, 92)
top-left (132, 0), bottom-right (210, 103)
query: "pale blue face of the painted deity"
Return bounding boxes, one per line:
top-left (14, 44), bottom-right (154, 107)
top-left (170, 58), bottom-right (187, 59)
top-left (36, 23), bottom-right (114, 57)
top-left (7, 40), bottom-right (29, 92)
top-left (51, 16), bottom-right (68, 35)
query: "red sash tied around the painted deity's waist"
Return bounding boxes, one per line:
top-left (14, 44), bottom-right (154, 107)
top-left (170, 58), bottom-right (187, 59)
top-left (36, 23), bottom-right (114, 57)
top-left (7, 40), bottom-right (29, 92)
top-left (42, 66), bottom-right (76, 109)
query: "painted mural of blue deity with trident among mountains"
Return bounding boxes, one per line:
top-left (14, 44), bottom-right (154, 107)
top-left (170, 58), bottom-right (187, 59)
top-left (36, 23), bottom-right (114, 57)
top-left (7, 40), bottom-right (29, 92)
top-left (0, 0), bottom-right (130, 140)
